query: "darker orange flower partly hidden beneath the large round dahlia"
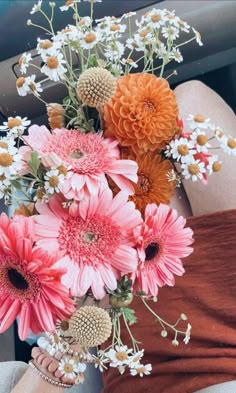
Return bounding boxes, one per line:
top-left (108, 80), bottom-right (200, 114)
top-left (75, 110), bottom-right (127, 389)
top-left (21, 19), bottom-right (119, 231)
top-left (110, 148), bottom-right (176, 213)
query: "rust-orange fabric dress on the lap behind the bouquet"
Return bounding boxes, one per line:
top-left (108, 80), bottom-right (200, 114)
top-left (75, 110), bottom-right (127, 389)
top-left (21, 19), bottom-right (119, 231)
top-left (103, 210), bottom-right (236, 393)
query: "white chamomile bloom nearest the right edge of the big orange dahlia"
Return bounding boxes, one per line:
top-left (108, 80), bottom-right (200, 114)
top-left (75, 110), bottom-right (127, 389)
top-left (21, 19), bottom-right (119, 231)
top-left (165, 138), bottom-right (196, 163)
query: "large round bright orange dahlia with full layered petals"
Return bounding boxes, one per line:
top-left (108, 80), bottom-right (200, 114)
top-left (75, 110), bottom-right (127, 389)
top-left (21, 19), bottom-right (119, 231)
top-left (104, 73), bottom-right (179, 152)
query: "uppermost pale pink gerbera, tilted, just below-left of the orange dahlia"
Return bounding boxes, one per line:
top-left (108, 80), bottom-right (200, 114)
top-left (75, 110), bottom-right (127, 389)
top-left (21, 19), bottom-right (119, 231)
top-left (22, 126), bottom-right (138, 200)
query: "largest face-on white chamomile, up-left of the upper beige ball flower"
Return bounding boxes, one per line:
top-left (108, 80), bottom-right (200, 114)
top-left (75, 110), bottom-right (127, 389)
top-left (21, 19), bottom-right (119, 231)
top-left (41, 53), bottom-right (67, 82)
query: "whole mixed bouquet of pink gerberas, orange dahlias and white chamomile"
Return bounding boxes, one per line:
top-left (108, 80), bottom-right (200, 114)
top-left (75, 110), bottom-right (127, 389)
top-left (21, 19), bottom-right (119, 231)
top-left (0, 0), bottom-right (236, 386)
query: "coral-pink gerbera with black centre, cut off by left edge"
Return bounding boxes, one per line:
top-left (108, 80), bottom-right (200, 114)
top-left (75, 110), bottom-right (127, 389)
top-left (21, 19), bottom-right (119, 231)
top-left (0, 213), bottom-right (74, 340)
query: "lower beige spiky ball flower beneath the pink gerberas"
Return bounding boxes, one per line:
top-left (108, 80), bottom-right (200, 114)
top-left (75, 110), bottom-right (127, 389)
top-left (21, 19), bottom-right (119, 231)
top-left (70, 306), bottom-right (112, 347)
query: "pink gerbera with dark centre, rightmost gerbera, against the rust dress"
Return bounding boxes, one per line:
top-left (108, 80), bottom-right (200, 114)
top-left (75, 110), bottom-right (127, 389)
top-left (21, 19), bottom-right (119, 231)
top-left (133, 204), bottom-right (193, 296)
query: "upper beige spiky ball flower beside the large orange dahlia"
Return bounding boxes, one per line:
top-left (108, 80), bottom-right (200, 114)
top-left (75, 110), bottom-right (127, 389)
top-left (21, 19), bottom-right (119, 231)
top-left (77, 67), bottom-right (116, 108)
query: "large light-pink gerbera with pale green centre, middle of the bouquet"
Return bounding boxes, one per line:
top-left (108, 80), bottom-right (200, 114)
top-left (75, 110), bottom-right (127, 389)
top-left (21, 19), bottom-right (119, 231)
top-left (35, 188), bottom-right (142, 299)
